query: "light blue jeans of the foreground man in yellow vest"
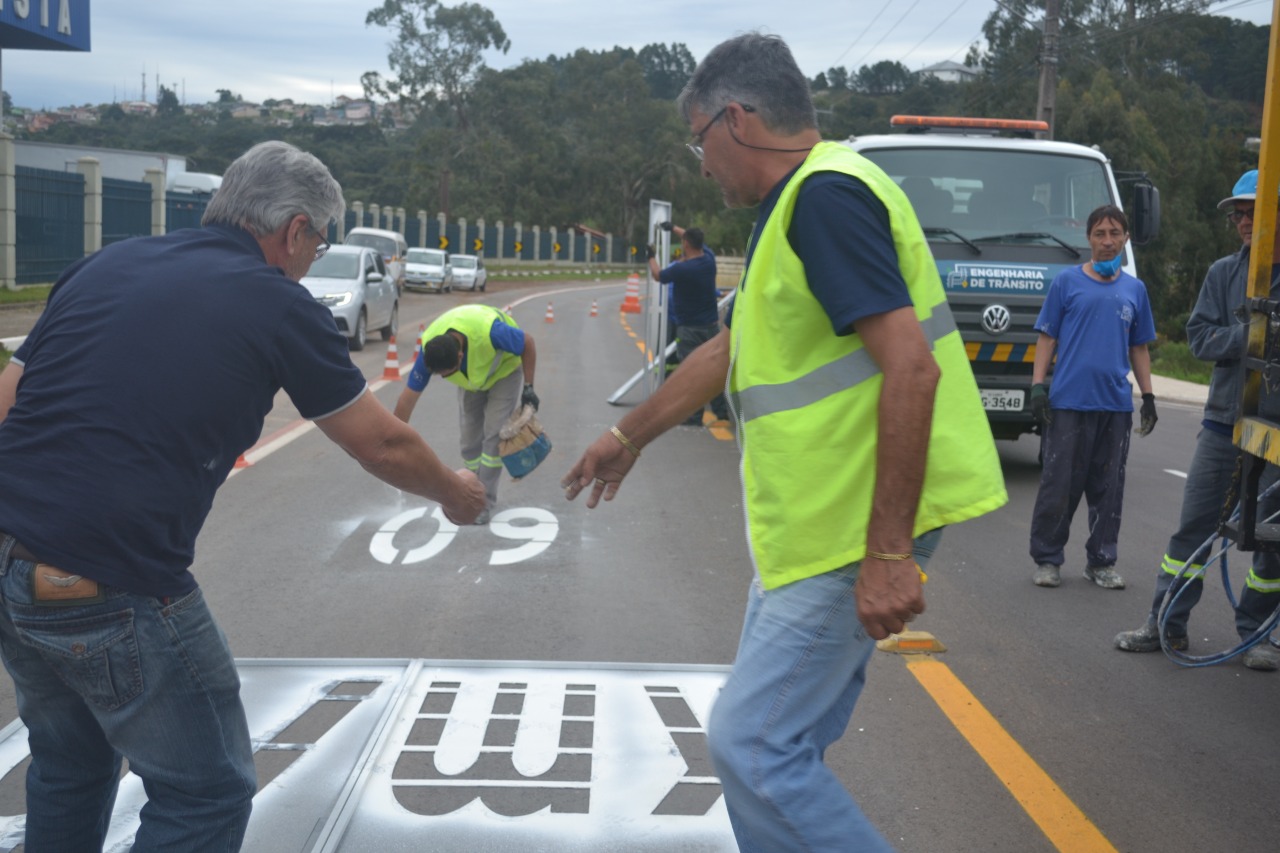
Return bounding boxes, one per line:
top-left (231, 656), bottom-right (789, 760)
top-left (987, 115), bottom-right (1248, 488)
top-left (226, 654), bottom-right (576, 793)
top-left (707, 530), bottom-right (942, 853)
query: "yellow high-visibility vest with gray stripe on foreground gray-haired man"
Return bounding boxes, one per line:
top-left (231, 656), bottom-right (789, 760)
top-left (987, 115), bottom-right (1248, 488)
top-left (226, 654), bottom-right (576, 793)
top-left (730, 142), bottom-right (1009, 589)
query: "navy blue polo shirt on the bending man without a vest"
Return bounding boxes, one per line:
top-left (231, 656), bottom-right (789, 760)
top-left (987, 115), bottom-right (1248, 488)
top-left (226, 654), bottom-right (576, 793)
top-left (0, 225), bottom-right (367, 596)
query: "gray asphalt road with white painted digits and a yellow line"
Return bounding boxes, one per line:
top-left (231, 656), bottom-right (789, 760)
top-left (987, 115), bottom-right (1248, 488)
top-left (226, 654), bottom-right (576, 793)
top-left (0, 280), bottom-right (1280, 853)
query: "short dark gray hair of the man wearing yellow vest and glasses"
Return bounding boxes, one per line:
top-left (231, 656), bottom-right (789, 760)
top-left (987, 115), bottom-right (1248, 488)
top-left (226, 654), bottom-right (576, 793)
top-left (676, 32), bottom-right (818, 136)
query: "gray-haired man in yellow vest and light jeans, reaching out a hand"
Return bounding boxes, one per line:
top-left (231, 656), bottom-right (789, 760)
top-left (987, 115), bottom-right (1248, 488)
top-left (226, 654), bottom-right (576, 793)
top-left (562, 33), bottom-right (1007, 853)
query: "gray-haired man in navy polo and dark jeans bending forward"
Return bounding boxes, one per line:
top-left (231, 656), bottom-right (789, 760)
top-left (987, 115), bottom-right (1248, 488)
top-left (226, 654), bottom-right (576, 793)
top-left (0, 136), bottom-right (484, 853)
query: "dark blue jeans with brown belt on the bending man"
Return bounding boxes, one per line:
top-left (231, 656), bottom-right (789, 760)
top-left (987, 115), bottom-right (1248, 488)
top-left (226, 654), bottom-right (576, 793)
top-left (0, 537), bottom-right (257, 853)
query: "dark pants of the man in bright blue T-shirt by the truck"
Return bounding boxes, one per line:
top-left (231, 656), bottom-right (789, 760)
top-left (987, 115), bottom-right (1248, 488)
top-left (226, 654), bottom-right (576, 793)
top-left (1032, 409), bottom-right (1133, 567)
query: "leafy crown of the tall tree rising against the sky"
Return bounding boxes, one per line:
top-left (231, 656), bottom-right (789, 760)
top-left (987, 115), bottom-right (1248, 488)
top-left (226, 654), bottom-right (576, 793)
top-left (361, 0), bottom-right (511, 131)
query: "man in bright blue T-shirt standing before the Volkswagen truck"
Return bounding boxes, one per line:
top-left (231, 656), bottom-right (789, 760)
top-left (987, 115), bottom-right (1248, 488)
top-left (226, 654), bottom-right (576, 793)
top-left (1030, 205), bottom-right (1156, 589)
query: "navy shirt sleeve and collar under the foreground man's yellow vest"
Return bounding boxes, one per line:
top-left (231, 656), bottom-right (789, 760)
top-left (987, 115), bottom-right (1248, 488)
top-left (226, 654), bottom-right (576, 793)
top-left (724, 167), bottom-right (911, 336)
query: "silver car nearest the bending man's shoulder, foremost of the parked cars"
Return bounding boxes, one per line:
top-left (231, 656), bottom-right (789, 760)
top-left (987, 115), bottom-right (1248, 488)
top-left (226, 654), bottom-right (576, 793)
top-left (302, 246), bottom-right (399, 350)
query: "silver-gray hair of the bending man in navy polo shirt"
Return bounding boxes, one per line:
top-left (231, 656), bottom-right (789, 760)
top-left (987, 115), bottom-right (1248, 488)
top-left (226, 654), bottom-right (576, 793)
top-left (201, 141), bottom-right (347, 237)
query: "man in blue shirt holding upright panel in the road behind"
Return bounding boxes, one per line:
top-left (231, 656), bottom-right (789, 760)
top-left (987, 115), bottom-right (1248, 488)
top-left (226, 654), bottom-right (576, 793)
top-left (648, 222), bottom-right (728, 427)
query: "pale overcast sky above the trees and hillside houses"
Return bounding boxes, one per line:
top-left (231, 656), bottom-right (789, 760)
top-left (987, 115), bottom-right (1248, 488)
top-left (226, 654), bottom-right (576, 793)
top-left (0, 0), bottom-right (1271, 109)
